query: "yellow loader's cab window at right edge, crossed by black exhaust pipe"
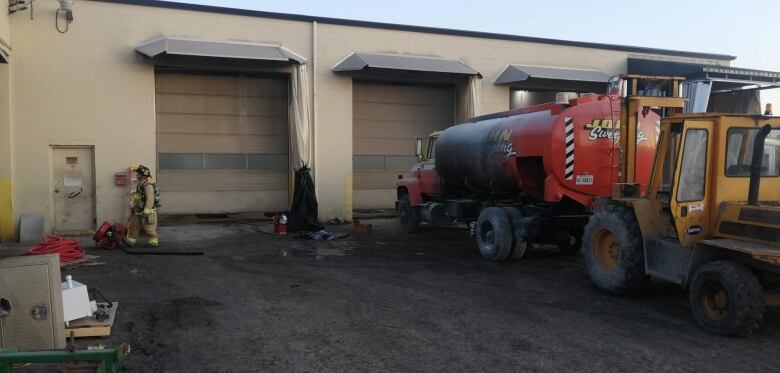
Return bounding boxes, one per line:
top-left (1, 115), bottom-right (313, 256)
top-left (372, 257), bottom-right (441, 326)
top-left (726, 128), bottom-right (780, 177)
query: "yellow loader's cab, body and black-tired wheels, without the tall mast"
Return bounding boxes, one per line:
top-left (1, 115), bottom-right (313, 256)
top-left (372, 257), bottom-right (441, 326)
top-left (582, 114), bottom-right (780, 336)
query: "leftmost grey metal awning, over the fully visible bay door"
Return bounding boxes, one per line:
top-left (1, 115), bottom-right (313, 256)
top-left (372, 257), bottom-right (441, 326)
top-left (135, 37), bottom-right (306, 63)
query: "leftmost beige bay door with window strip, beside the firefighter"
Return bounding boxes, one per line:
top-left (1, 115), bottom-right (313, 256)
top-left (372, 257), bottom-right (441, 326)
top-left (156, 73), bottom-right (289, 213)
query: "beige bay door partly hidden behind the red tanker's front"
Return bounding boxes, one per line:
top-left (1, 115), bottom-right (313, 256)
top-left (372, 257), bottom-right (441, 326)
top-left (352, 82), bottom-right (455, 209)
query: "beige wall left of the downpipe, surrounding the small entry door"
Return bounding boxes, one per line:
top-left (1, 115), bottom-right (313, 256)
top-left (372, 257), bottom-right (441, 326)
top-left (6, 1), bottom-right (311, 234)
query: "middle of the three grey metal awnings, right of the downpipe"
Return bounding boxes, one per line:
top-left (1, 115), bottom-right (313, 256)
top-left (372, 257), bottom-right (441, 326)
top-left (332, 52), bottom-right (479, 75)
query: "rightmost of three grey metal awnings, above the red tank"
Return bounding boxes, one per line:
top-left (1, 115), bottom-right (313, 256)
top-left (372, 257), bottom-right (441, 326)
top-left (494, 65), bottom-right (610, 91)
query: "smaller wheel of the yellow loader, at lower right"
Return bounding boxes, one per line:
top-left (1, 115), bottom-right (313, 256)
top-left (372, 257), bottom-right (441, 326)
top-left (690, 261), bottom-right (764, 337)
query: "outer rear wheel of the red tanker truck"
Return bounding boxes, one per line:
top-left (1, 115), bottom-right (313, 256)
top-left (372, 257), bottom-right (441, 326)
top-left (477, 207), bottom-right (512, 261)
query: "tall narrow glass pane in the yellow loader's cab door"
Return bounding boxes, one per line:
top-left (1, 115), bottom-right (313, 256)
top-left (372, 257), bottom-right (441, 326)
top-left (677, 128), bottom-right (707, 202)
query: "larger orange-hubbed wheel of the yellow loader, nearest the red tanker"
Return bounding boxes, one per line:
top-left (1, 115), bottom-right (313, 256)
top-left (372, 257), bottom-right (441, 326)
top-left (582, 205), bottom-right (650, 295)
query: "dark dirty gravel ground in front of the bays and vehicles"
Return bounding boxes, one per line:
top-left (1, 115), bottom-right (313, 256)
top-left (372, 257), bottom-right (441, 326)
top-left (6, 220), bottom-right (780, 372)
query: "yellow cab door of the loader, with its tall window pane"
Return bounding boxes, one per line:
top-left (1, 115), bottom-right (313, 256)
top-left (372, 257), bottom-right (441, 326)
top-left (670, 121), bottom-right (714, 247)
